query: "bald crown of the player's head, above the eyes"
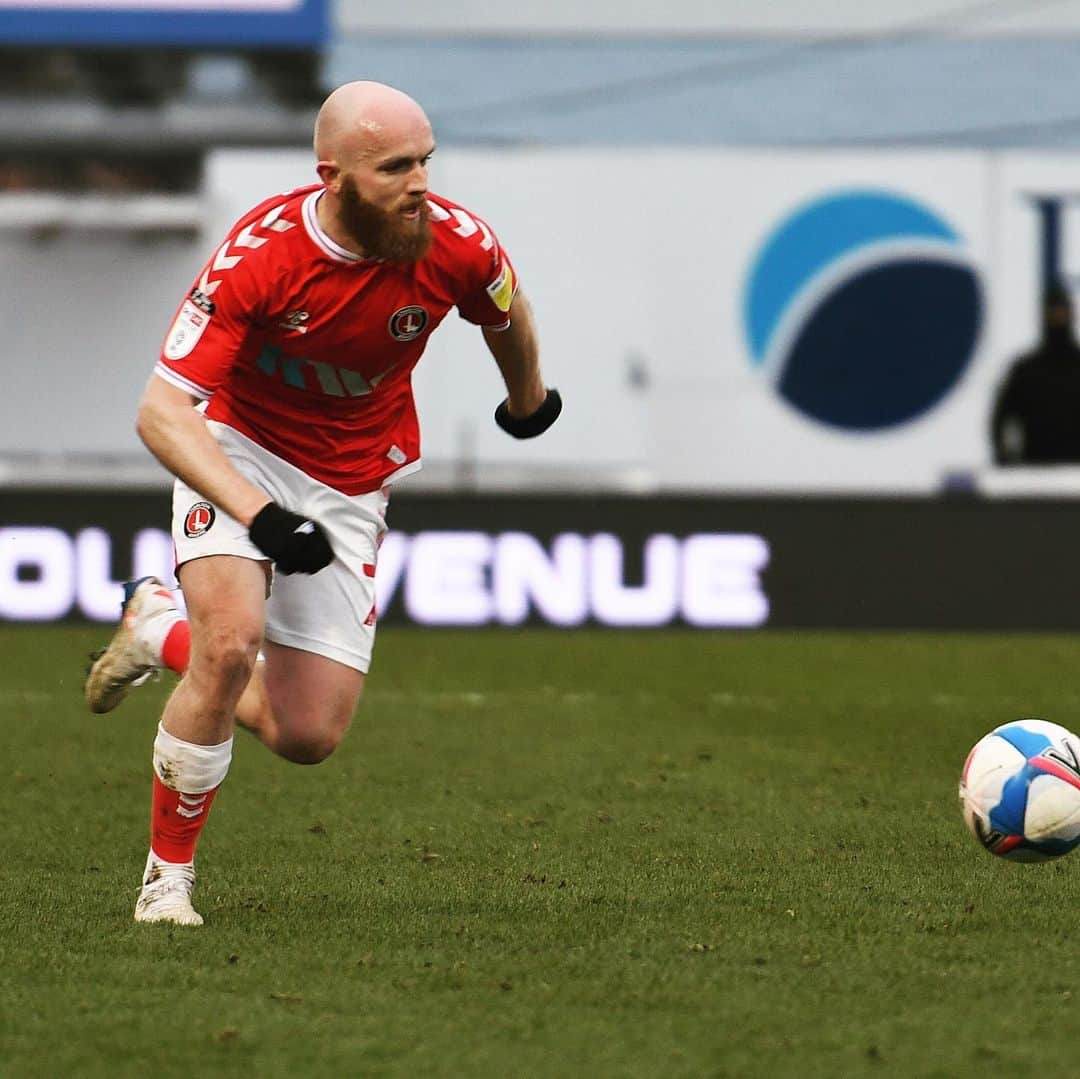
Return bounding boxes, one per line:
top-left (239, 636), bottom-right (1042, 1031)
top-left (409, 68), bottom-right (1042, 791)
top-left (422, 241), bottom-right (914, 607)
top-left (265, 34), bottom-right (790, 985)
top-left (315, 82), bottom-right (431, 166)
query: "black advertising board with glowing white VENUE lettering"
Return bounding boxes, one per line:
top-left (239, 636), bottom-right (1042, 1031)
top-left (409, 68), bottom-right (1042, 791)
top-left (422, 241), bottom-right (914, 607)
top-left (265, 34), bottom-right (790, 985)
top-left (8, 491), bottom-right (1080, 631)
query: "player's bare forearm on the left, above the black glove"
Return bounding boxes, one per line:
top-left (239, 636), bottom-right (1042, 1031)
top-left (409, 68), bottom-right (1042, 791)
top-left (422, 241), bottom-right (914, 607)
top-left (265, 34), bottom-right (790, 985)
top-left (135, 375), bottom-right (270, 528)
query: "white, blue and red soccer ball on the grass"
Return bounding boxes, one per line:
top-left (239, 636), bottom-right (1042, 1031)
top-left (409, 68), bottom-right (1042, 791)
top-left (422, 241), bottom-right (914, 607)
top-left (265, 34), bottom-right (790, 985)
top-left (960, 719), bottom-right (1080, 862)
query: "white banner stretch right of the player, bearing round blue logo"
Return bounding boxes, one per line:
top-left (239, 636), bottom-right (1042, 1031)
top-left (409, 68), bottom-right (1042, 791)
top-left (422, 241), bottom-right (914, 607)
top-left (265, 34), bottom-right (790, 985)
top-left (418, 148), bottom-right (1080, 493)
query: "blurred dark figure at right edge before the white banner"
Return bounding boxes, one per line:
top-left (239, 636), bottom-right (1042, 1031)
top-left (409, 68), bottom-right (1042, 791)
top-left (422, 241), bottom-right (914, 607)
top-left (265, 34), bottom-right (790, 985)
top-left (990, 285), bottom-right (1080, 464)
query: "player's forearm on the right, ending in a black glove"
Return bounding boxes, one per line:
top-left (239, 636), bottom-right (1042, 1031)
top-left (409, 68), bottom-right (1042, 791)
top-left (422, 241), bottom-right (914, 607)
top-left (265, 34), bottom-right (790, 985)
top-left (483, 289), bottom-right (563, 439)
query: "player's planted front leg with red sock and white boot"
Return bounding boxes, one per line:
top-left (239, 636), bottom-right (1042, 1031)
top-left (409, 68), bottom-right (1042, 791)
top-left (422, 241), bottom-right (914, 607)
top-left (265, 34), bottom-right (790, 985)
top-left (135, 555), bottom-right (266, 925)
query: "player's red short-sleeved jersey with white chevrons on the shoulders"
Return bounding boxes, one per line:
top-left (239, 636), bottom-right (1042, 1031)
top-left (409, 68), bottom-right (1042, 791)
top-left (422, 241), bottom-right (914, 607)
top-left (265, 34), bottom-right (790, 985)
top-left (156, 185), bottom-right (517, 495)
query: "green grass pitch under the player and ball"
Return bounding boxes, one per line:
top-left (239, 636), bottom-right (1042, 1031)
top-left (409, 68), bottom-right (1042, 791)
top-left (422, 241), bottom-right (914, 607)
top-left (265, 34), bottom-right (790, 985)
top-left (6, 629), bottom-right (1080, 1079)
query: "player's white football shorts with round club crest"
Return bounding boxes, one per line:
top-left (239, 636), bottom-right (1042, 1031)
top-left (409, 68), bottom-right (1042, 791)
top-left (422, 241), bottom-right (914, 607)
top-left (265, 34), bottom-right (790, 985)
top-left (173, 420), bottom-right (389, 674)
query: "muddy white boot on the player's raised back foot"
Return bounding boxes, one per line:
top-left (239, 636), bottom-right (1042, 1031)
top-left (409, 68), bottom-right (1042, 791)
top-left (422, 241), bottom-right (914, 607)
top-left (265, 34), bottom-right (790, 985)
top-left (83, 577), bottom-right (176, 713)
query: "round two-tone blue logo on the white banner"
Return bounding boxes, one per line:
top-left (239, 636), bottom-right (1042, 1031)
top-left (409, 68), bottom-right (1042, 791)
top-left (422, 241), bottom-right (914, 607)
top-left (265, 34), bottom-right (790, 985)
top-left (743, 191), bottom-right (983, 431)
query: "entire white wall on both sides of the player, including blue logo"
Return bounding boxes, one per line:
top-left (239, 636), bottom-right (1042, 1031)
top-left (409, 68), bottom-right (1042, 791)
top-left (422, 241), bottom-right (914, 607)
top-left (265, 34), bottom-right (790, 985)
top-left (8, 147), bottom-right (1080, 494)
